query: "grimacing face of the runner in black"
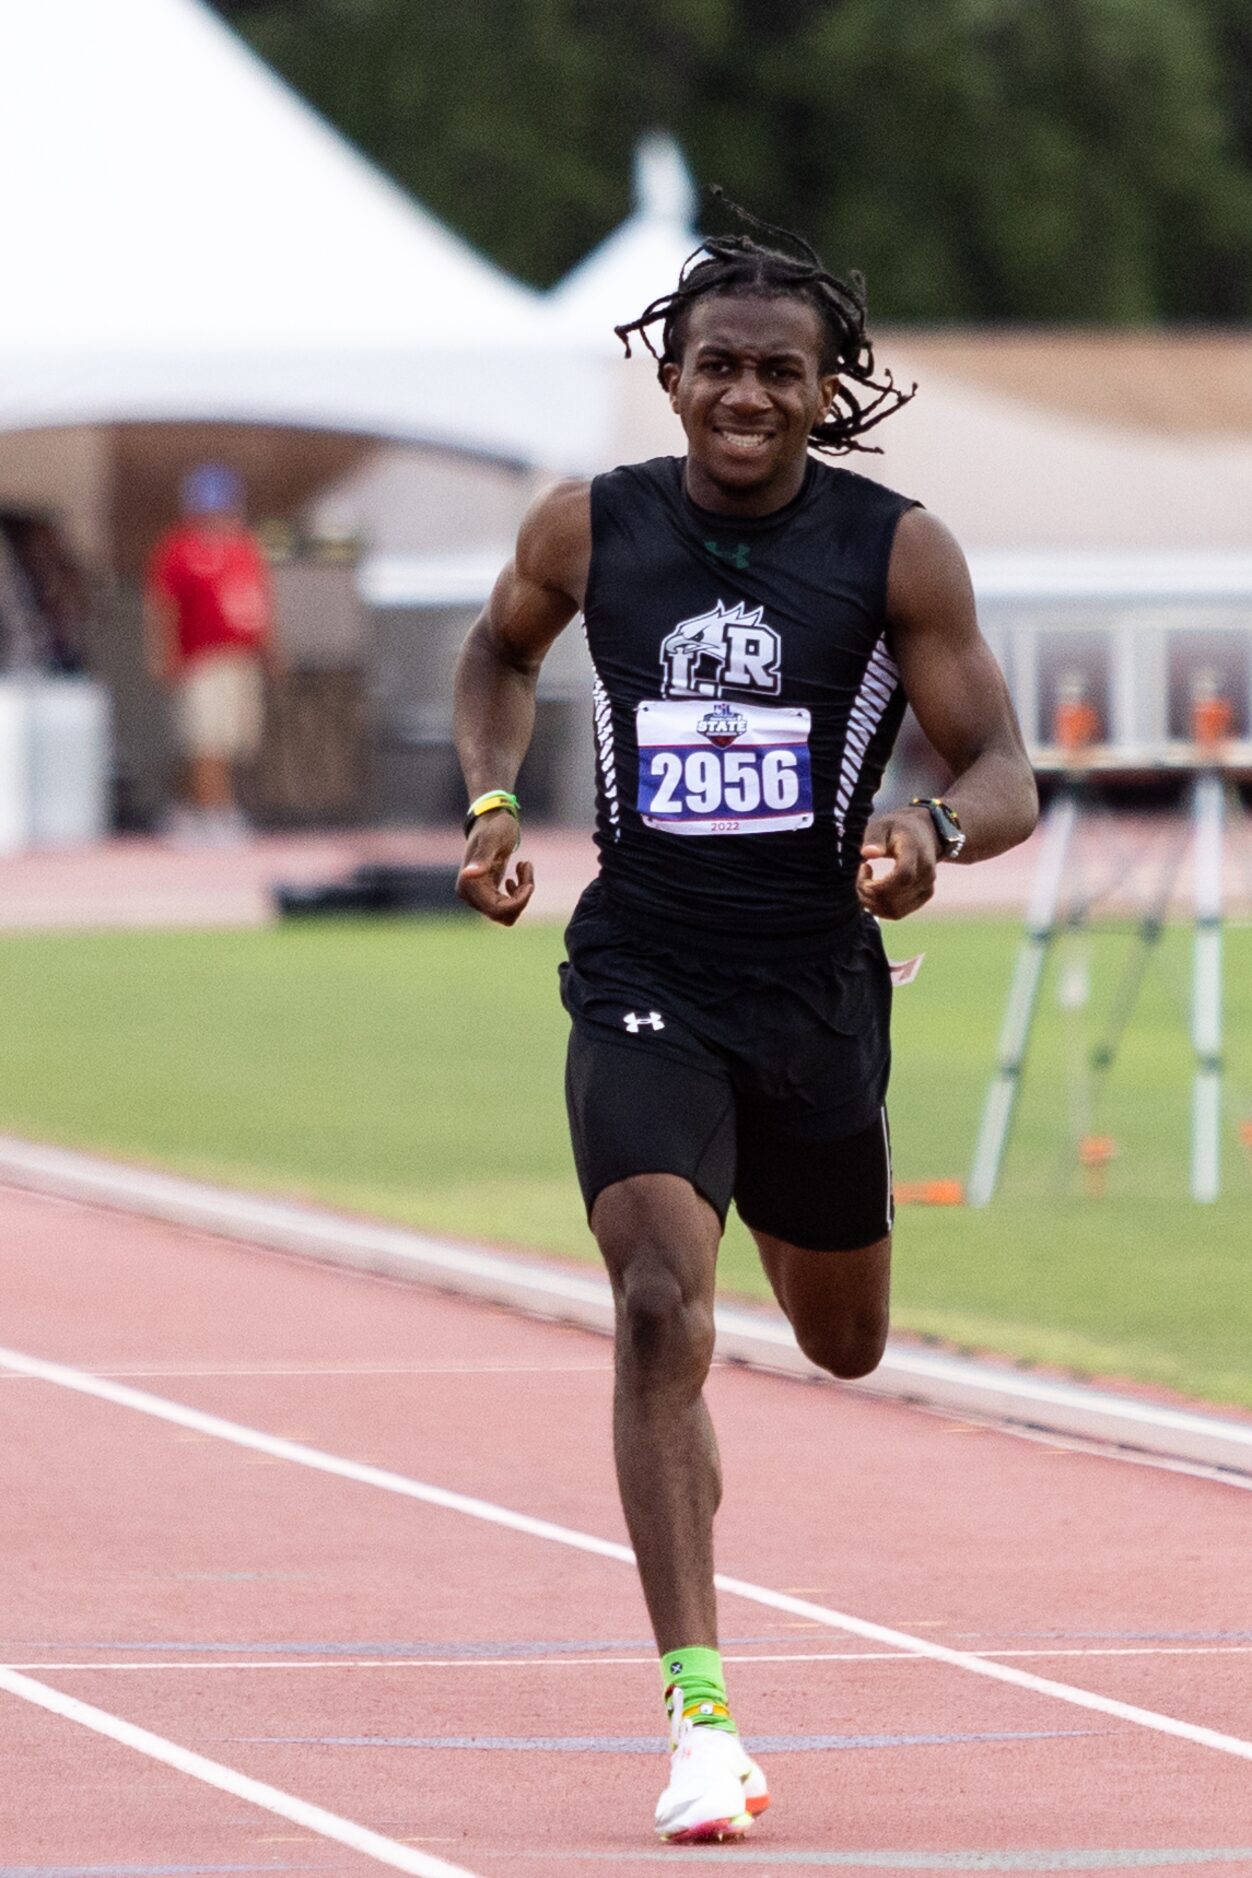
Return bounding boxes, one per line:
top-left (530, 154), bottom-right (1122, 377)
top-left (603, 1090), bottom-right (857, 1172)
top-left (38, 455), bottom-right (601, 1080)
top-left (666, 295), bottom-right (839, 515)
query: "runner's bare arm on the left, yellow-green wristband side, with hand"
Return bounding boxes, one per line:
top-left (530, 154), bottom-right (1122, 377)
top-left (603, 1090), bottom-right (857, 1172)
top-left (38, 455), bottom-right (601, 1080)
top-left (454, 483), bottom-right (591, 926)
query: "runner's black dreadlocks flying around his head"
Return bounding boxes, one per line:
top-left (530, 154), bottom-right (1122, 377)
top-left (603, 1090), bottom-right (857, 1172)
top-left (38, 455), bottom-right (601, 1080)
top-left (614, 186), bottom-right (918, 456)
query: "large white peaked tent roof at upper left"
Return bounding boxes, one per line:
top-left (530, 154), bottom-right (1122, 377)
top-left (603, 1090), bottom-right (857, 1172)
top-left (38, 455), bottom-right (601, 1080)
top-left (0, 0), bottom-right (586, 466)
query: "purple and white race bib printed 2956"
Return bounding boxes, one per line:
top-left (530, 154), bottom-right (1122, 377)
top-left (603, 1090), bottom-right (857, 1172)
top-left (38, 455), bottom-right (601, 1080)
top-left (634, 699), bottom-right (813, 834)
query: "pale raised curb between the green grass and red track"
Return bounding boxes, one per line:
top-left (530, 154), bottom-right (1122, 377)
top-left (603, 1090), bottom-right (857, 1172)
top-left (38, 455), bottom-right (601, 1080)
top-left (0, 1136), bottom-right (1252, 1476)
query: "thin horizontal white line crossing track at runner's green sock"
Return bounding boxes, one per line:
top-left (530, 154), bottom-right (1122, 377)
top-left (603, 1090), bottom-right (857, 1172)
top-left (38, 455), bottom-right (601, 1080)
top-left (0, 1643), bottom-right (1252, 1675)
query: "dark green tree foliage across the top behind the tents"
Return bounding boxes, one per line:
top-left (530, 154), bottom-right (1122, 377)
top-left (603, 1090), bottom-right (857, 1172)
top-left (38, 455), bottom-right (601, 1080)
top-left (220, 0), bottom-right (1252, 323)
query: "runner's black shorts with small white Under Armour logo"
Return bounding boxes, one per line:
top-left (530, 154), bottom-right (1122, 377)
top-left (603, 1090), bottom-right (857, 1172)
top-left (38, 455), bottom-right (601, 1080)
top-left (561, 883), bottom-right (892, 1251)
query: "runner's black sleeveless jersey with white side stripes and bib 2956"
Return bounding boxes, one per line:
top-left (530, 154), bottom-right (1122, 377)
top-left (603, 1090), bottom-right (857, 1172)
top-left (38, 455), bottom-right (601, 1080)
top-left (584, 456), bottom-right (912, 943)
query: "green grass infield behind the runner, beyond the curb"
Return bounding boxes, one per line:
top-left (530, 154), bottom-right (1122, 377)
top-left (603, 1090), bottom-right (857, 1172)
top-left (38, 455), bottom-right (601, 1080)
top-left (0, 916), bottom-right (1252, 1407)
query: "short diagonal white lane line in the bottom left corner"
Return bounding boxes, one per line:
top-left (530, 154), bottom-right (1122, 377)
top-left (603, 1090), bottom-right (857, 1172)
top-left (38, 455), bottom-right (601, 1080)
top-left (0, 1670), bottom-right (477, 1878)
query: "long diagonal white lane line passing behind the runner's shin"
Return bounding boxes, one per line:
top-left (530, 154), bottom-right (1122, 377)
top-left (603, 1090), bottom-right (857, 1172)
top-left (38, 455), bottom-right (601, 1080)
top-left (0, 1347), bottom-right (1252, 1762)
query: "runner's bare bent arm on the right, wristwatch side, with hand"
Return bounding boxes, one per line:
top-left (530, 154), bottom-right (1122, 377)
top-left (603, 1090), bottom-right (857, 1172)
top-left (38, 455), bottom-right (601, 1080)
top-left (858, 509), bottom-right (1038, 920)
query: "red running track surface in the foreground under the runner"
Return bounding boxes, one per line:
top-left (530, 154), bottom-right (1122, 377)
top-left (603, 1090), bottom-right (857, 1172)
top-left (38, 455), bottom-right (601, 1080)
top-left (0, 1193), bottom-right (1252, 1878)
